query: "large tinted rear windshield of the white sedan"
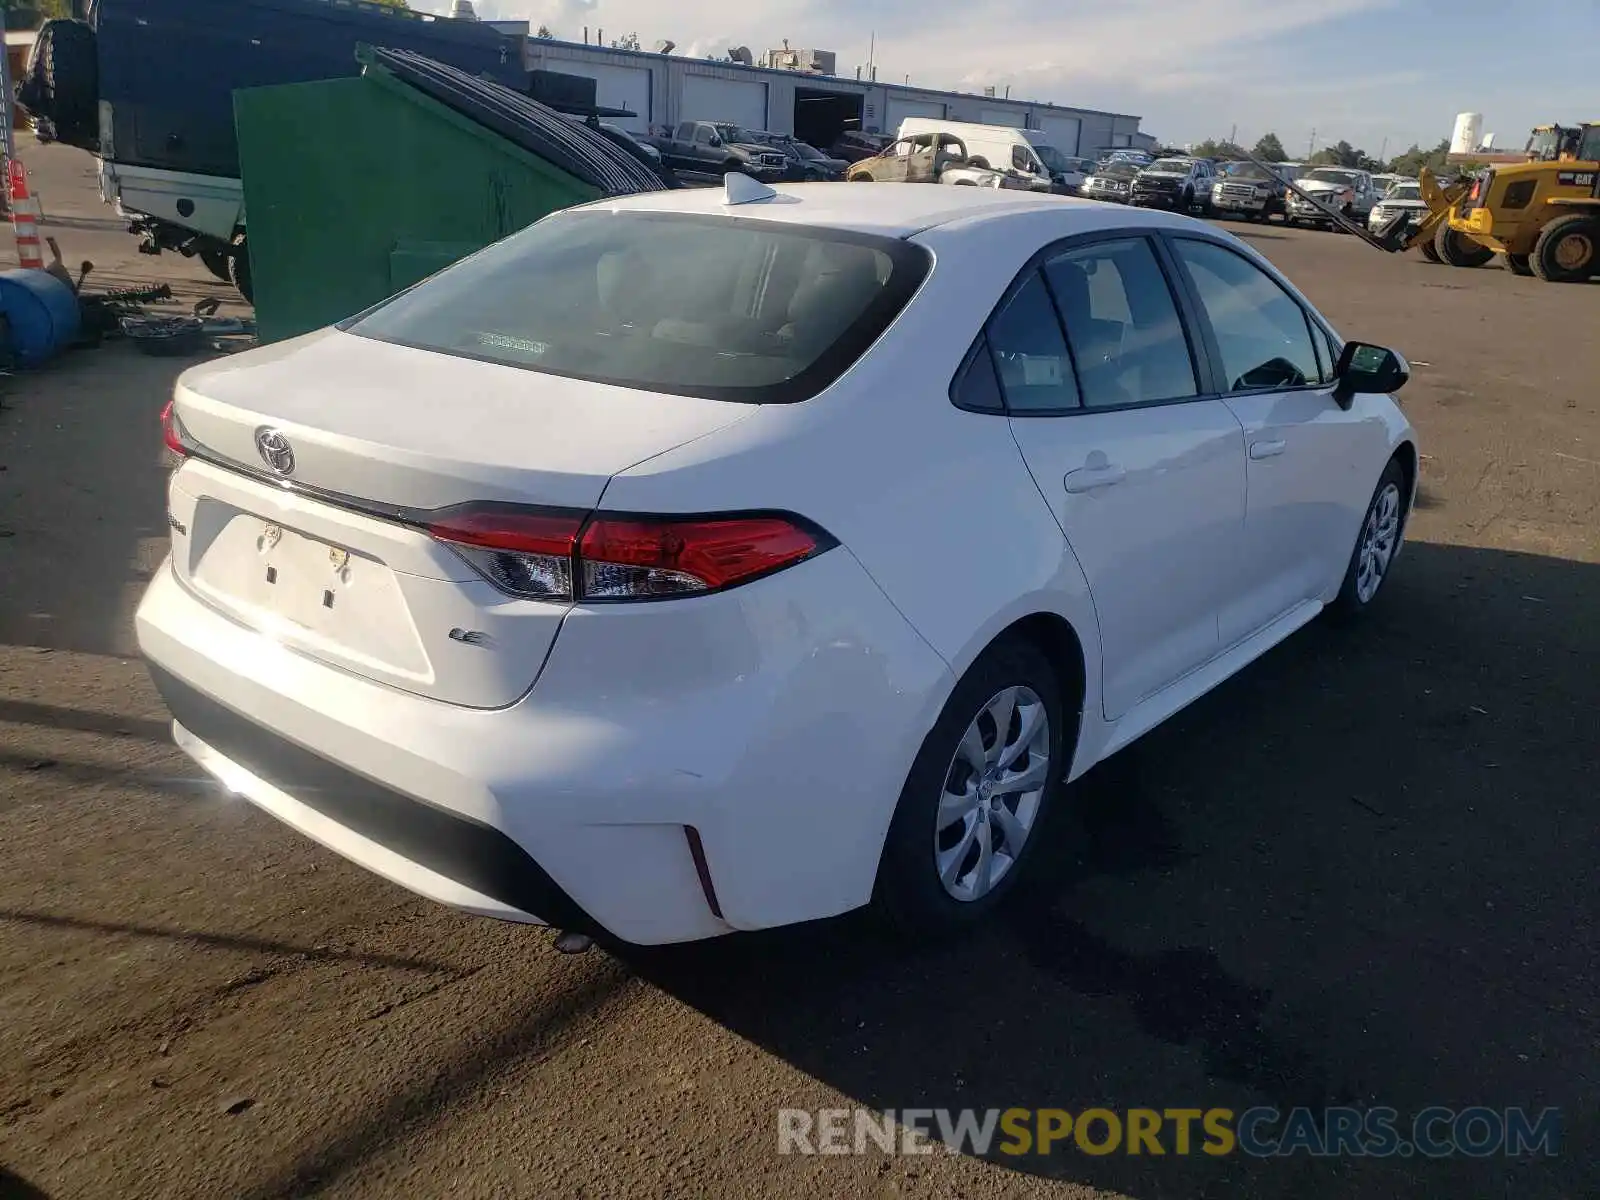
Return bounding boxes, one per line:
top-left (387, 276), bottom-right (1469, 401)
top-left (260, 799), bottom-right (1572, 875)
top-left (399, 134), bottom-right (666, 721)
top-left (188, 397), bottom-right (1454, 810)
top-left (341, 211), bottom-right (928, 403)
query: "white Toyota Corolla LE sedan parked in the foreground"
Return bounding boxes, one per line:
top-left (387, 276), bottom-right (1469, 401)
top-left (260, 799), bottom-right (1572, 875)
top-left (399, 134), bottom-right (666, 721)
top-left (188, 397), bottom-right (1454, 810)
top-left (138, 178), bottom-right (1418, 942)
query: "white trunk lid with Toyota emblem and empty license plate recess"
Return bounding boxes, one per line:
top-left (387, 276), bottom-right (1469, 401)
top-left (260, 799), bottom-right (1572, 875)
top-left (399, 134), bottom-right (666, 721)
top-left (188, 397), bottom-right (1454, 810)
top-left (168, 331), bottom-right (755, 707)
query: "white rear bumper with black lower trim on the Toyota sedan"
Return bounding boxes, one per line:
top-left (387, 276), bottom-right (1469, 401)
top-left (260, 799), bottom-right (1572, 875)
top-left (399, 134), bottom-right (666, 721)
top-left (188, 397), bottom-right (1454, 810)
top-left (136, 547), bottom-right (950, 944)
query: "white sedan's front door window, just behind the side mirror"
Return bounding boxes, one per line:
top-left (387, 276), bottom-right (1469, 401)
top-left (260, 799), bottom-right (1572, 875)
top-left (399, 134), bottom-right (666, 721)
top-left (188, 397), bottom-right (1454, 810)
top-left (1174, 238), bottom-right (1322, 392)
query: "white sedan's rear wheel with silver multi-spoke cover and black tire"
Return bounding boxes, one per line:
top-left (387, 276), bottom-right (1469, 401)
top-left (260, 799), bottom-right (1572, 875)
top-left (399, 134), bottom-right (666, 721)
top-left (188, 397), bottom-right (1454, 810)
top-left (874, 638), bottom-right (1070, 939)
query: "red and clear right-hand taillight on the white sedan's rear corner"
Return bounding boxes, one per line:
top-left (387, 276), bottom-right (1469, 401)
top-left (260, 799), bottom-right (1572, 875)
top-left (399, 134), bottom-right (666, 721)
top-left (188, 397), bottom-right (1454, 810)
top-left (427, 504), bottom-right (832, 602)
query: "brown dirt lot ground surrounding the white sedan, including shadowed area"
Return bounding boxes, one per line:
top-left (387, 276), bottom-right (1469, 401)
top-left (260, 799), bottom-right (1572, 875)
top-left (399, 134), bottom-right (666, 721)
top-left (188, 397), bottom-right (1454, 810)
top-left (0, 143), bottom-right (1600, 1200)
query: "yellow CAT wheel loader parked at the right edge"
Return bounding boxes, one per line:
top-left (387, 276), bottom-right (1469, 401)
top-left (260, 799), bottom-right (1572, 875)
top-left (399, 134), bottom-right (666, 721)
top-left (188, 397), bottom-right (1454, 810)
top-left (1427, 123), bottom-right (1600, 283)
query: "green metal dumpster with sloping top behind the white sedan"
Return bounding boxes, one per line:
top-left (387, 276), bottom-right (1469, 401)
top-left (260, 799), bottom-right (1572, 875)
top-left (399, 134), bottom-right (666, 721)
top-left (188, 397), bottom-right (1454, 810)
top-left (234, 64), bottom-right (600, 342)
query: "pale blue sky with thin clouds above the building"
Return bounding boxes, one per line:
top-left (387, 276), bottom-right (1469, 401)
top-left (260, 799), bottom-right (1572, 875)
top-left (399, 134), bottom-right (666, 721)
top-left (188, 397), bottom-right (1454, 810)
top-left (425, 0), bottom-right (1600, 157)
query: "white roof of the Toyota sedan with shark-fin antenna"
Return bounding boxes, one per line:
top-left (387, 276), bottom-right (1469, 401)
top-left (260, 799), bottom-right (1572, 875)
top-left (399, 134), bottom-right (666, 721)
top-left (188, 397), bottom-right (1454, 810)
top-left (586, 182), bottom-right (1132, 237)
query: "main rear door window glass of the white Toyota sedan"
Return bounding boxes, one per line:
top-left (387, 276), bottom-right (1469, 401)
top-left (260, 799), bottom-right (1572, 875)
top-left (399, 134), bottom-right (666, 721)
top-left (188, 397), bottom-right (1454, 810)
top-left (1045, 238), bottom-right (1200, 408)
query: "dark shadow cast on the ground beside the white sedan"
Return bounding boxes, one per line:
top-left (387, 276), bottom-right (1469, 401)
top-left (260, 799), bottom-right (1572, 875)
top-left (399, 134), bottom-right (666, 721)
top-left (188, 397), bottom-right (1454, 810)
top-left (629, 544), bottom-right (1600, 1200)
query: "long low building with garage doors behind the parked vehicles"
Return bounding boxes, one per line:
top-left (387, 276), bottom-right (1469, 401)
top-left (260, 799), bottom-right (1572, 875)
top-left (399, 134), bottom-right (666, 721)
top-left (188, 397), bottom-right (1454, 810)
top-left (526, 38), bottom-right (1149, 155)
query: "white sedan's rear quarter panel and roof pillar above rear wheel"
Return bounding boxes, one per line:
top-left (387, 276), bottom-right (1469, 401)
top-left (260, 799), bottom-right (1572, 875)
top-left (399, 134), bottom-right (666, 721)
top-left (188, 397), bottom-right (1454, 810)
top-left (602, 206), bottom-right (1177, 765)
